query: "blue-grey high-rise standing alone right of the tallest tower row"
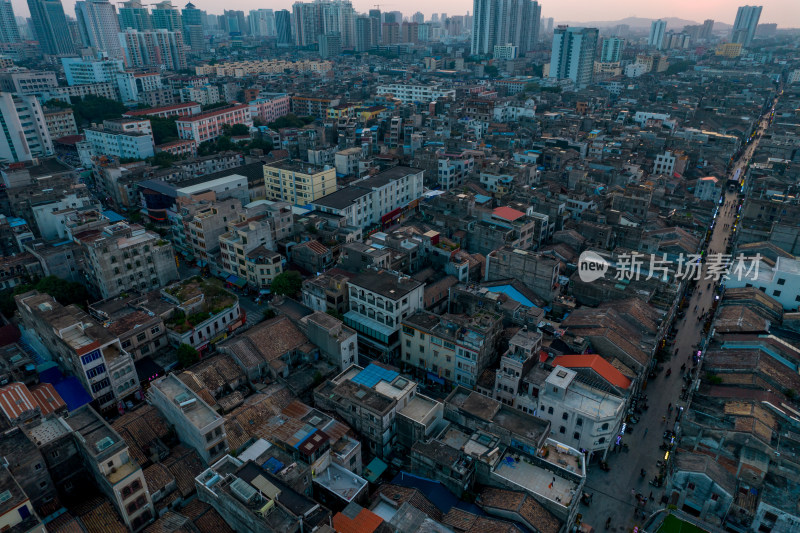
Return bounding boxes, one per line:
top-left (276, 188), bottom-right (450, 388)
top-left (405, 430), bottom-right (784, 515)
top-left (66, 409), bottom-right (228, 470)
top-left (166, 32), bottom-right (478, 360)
top-left (549, 26), bottom-right (598, 87)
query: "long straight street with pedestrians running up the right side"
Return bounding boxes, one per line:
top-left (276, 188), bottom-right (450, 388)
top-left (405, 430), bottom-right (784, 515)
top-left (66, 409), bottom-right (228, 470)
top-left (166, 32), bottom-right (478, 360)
top-left (579, 103), bottom-right (766, 532)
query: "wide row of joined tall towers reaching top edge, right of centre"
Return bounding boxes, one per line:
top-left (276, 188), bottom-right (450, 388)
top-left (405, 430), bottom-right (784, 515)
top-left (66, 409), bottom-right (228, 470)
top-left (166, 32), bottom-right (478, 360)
top-left (472, 0), bottom-right (542, 55)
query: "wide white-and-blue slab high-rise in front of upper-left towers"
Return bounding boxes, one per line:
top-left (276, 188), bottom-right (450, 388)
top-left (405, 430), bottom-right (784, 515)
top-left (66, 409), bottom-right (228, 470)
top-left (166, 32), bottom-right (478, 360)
top-left (119, 28), bottom-right (186, 70)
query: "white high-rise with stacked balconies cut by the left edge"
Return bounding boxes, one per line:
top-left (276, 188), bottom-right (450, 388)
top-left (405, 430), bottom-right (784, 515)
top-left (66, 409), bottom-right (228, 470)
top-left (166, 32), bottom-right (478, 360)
top-left (0, 92), bottom-right (53, 163)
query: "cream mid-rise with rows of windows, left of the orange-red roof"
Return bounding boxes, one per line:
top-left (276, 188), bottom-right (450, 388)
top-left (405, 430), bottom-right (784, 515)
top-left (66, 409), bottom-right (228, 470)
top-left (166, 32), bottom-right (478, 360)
top-left (400, 311), bottom-right (503, 388)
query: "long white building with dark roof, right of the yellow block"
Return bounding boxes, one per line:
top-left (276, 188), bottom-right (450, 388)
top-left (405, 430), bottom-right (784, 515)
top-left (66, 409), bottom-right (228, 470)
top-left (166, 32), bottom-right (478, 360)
top-left (311, 166), bottom-right (424, 228)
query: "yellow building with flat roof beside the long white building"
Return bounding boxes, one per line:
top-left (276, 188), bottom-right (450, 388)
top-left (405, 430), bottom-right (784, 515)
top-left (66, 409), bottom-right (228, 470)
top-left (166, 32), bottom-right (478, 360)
top-left (264, 159), bottom-right (336, 205)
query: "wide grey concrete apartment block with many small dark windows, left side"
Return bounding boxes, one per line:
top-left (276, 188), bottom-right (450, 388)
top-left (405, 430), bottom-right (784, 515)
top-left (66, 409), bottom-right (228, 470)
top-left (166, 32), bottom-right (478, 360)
top-left (74, 222), bottom-right (178, 299)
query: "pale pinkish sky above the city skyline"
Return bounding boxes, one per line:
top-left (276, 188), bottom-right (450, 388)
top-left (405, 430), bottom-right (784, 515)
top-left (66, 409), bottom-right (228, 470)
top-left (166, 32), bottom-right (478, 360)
top-left (11, 0), bottom-right (800, 28)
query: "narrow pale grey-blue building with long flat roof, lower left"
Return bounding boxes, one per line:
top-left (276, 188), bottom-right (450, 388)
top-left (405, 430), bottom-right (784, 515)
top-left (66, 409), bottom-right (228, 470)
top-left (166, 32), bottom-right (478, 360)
top-left (147, 374), bottom-right (228, 464)
